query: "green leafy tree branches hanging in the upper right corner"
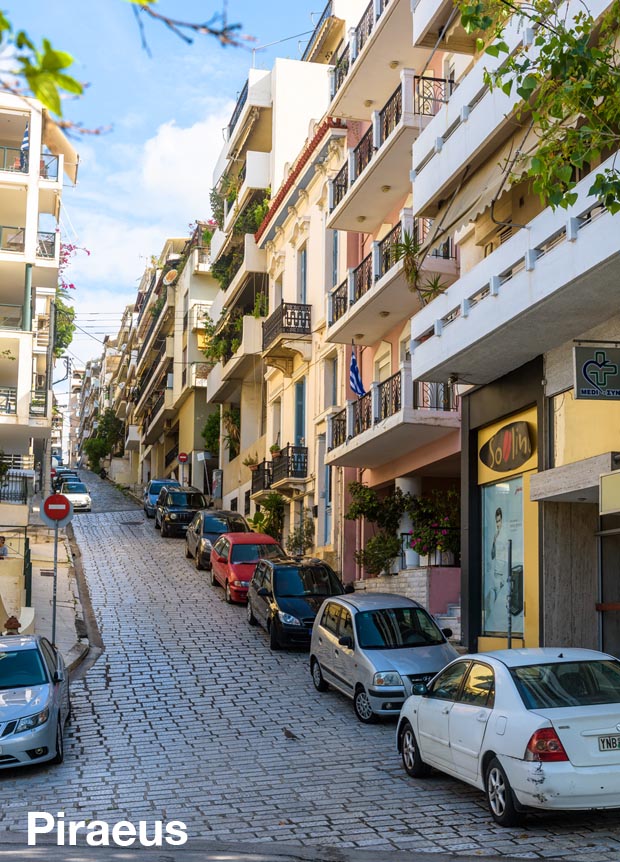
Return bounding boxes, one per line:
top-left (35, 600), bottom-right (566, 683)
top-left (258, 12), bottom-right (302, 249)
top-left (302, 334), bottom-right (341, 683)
top-left (458, 0), bottom-right (620, 213)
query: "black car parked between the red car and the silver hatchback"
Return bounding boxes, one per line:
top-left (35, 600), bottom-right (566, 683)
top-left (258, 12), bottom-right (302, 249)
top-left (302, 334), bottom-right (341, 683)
top-left (247, 558), bottom-right (354, 649)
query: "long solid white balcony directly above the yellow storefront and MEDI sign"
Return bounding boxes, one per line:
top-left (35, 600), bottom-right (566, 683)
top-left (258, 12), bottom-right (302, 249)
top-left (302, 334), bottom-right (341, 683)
top-left (411, 156), bottom-right (620, 384)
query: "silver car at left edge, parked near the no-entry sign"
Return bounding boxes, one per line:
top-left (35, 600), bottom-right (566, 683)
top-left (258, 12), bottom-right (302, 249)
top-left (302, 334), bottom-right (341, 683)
top-left (0, 635), bottom-right (71, 769)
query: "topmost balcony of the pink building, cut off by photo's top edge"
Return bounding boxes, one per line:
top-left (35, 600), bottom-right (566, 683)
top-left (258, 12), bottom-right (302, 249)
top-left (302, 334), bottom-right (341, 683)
top-left (329, 0), bottom-right (428, 120)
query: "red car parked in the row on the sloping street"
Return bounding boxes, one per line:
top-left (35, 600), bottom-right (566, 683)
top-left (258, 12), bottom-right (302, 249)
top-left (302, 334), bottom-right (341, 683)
top-left (211, 533), bottom-right (288, 603)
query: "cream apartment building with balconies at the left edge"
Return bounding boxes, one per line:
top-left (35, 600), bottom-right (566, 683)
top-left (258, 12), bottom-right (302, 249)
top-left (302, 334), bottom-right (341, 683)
top-left (0, 93), bottom-right (78, 500)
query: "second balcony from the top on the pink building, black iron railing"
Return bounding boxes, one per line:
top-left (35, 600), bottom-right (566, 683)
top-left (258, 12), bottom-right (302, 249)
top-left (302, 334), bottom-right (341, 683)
top-left (327, 69), bottom-right (455, 233)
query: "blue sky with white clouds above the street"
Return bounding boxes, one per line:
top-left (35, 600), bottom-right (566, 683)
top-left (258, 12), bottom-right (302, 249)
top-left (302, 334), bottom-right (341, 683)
top-left (4, 0), bottom-right (324, 364)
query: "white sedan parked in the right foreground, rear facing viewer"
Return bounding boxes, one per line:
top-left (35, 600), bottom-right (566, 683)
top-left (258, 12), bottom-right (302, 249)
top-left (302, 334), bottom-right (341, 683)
top-left (397, 647), bottom-right (620, 826)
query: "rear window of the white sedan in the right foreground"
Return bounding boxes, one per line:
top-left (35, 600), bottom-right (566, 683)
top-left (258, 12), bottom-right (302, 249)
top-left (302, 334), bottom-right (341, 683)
top-left (510, 659), bottom-right (620, 709)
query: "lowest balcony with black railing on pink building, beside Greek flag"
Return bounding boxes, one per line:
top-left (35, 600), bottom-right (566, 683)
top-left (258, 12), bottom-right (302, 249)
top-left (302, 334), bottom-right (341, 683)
top-left (325, 364), bottom-right (460, 468)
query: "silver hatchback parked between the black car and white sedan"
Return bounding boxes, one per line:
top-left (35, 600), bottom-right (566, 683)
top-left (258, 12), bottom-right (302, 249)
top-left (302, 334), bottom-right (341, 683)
top-left (310, 592), bottom-right (457, 723)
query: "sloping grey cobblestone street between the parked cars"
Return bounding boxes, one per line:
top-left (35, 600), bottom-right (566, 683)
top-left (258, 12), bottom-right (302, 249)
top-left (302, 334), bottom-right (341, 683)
top-left (1, 475), bottom-right (620, 862)
